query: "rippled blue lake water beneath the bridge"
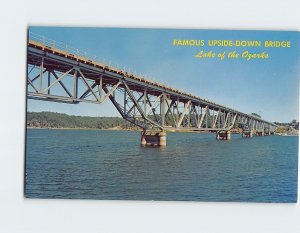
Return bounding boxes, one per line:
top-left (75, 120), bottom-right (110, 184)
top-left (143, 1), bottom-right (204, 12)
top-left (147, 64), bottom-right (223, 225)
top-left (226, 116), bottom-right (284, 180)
top-left (25, 129), bottom-right (298, 202)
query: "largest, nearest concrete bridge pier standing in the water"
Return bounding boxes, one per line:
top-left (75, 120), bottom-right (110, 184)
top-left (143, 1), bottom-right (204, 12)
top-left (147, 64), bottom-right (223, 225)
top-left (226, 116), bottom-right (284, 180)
top-left (141, 130), bottom-right (167, 146)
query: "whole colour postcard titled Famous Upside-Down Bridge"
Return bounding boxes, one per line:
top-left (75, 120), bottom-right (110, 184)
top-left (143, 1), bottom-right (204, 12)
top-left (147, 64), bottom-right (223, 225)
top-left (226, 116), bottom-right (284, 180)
top-left (24, 27), bottom-right (300, 203)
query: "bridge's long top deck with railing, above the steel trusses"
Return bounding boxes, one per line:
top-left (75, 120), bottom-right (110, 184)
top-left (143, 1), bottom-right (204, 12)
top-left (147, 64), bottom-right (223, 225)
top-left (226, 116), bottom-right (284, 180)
top-left (27, 39), bottom-right (276, 126)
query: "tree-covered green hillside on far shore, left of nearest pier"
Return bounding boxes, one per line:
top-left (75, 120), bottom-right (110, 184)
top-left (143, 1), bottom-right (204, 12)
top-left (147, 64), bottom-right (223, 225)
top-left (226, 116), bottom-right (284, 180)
top-left (27, 112), bottom-right (136, 129)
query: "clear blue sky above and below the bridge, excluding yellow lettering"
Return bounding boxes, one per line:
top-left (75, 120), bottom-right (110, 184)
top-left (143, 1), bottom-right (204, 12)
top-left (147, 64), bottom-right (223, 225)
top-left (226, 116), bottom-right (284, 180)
top-left (28, 27), bottom-right (300, 122)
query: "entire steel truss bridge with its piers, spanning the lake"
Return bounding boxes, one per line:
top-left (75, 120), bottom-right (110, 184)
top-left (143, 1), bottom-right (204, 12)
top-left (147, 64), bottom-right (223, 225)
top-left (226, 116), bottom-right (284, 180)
top-left (27, 33), bottom-right (276, 145)
